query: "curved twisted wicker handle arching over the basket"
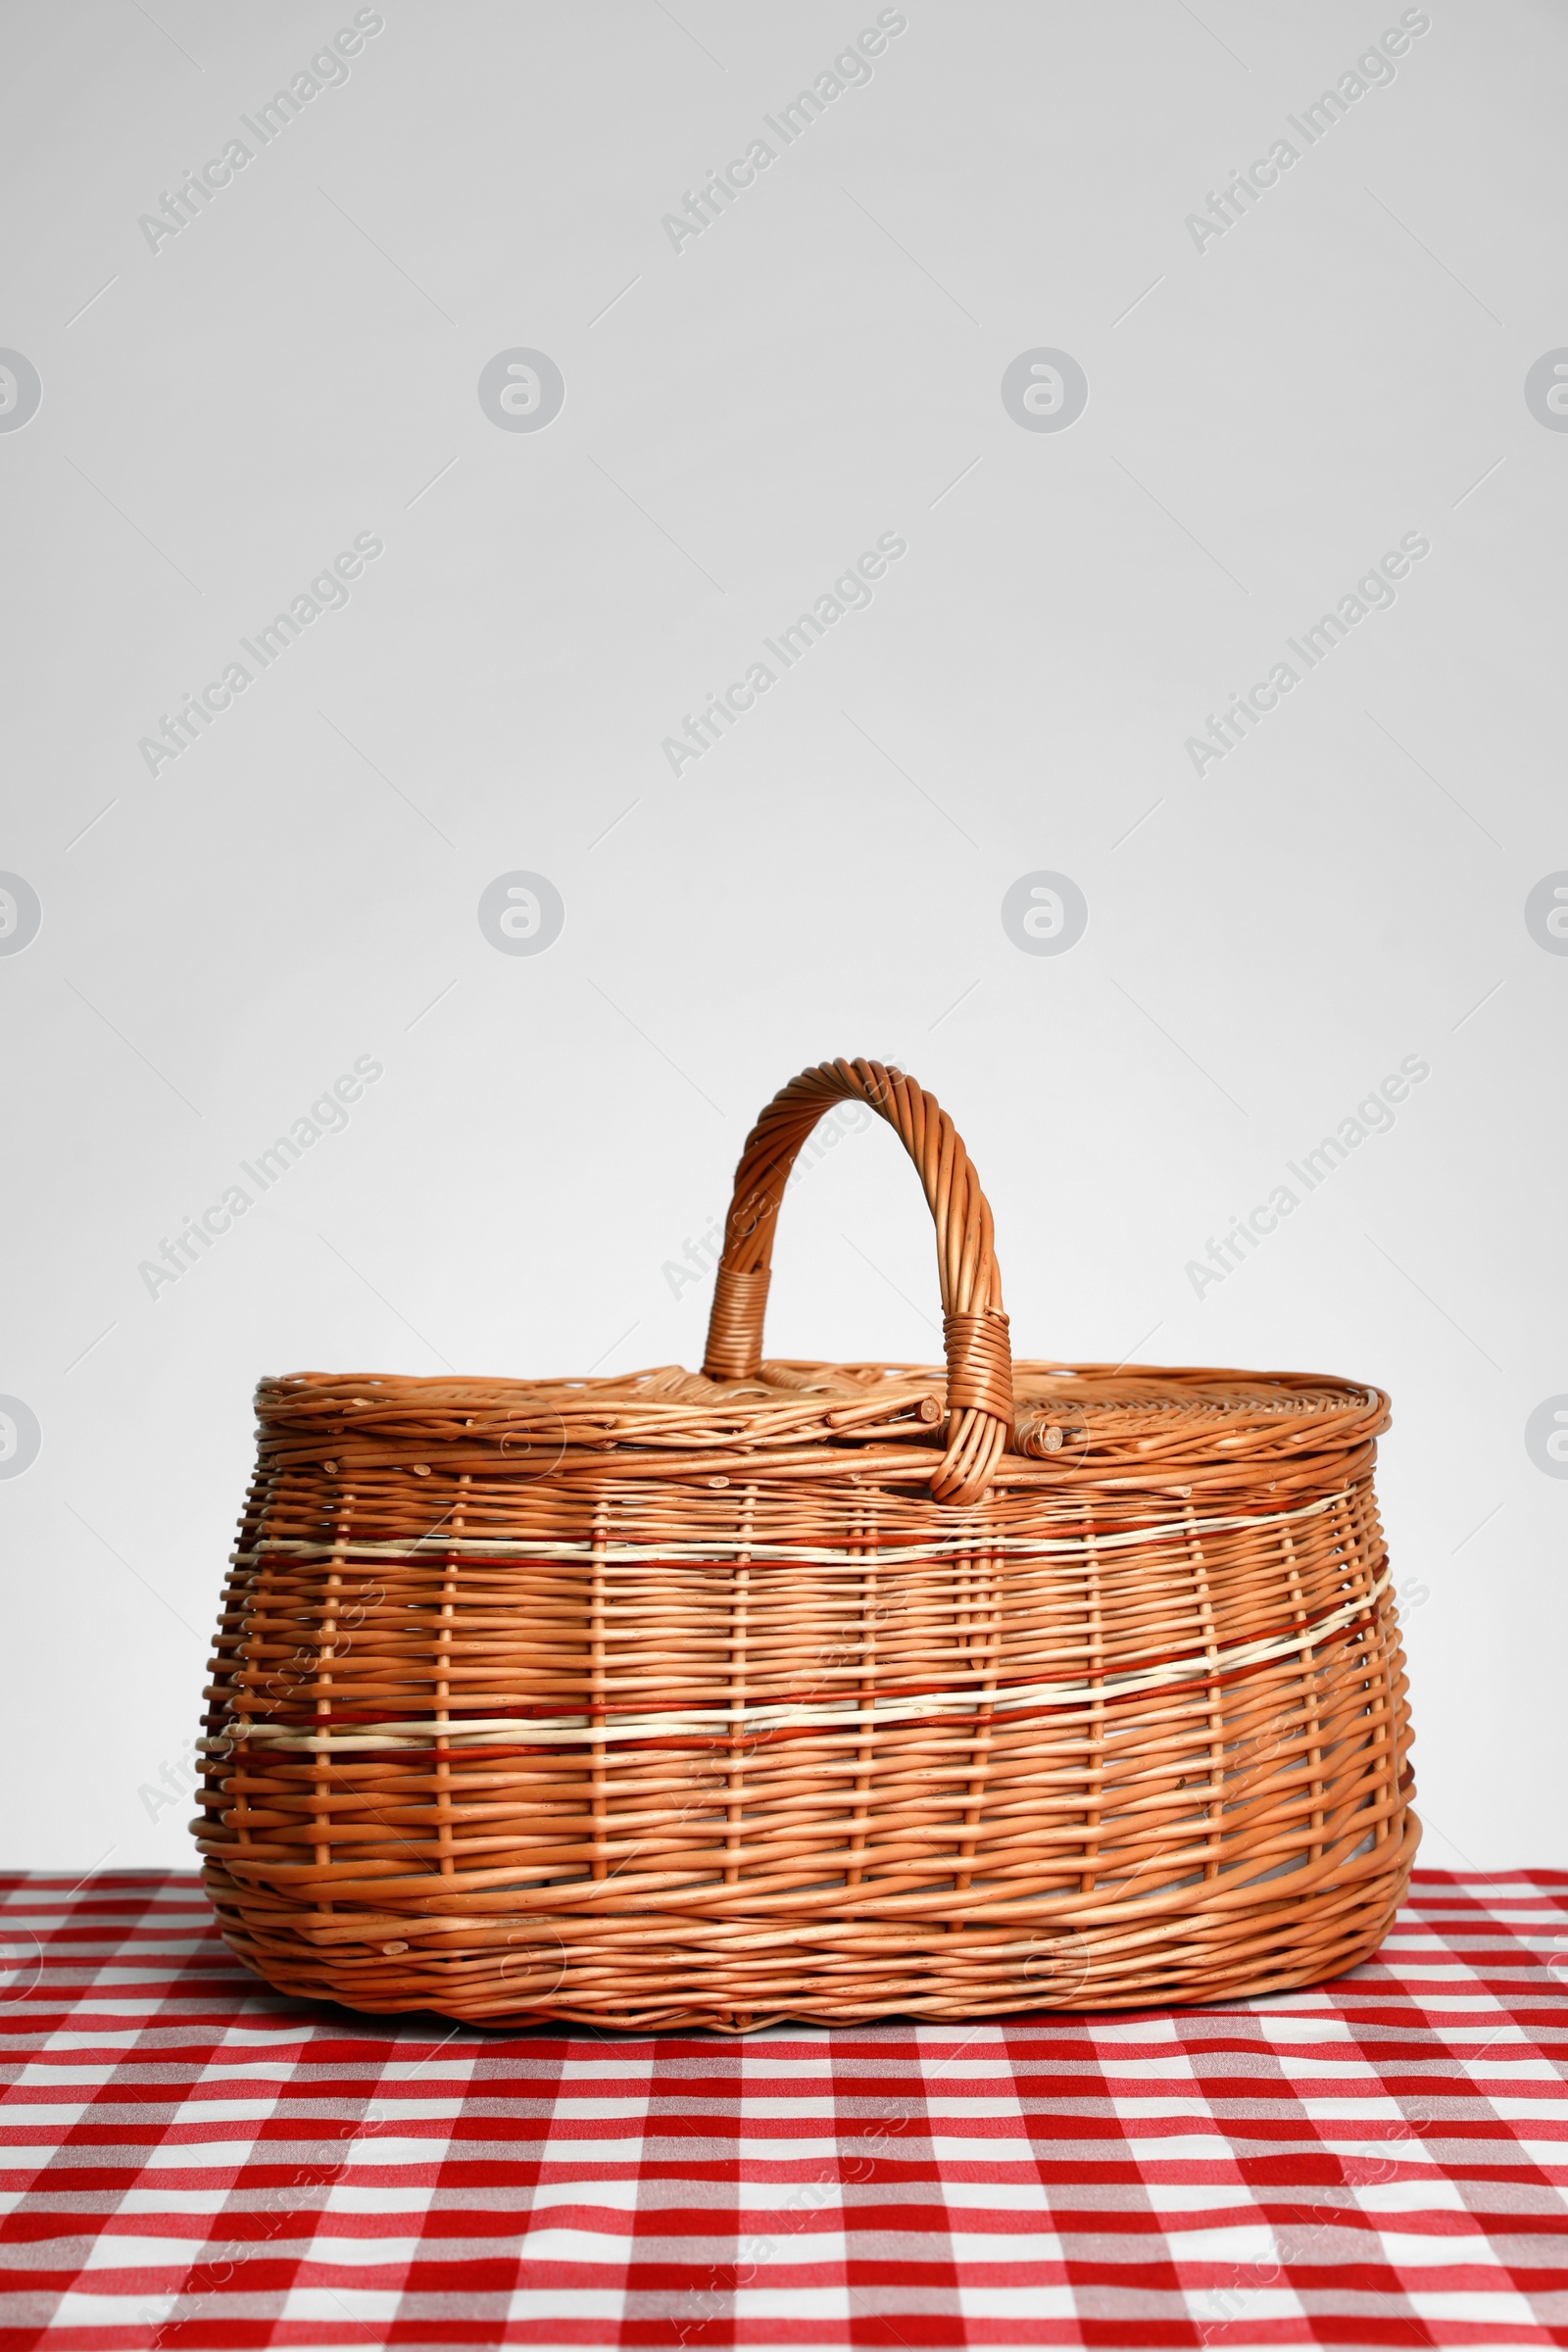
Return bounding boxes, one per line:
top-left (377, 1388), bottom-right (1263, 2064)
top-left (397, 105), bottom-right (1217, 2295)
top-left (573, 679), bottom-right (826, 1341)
top-left (703, 1060), bottom-right (1013, 1503)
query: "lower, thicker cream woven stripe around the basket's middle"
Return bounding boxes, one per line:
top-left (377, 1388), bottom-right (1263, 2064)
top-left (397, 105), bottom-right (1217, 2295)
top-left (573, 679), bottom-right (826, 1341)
top-left (215, 1569), bottom-right (1392, 1754)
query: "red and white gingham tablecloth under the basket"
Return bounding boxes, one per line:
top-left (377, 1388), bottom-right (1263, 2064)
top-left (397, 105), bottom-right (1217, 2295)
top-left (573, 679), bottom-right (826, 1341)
top-left (0, 1870), bottom-right (1568, 2352)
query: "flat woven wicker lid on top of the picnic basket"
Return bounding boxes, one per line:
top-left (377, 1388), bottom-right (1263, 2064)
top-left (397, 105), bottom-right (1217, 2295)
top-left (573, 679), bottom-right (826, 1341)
top-left (256, 1359), bottom-right (1390, 1492)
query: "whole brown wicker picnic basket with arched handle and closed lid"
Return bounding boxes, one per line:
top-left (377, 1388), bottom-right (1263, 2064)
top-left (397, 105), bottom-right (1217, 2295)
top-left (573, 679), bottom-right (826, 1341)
top-left (195, 1060), bottom-right (1420, 2033)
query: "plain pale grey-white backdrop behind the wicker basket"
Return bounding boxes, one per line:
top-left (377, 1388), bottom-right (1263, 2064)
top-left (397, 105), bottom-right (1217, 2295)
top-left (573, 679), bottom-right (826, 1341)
top-left (0, 0), bottom-right (1568, 1870)
